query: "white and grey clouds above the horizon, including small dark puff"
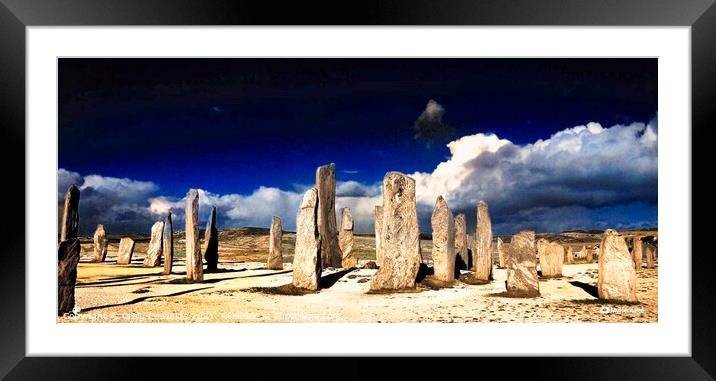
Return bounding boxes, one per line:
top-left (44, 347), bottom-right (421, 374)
top-left (58, 119), bottom-right (658, 234)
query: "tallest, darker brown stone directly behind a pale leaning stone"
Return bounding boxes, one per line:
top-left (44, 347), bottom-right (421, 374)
top-left (316, 163), bottom-right (343, 269)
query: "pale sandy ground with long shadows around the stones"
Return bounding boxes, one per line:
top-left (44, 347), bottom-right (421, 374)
top-left (58, 230), bottom-right (658, 323)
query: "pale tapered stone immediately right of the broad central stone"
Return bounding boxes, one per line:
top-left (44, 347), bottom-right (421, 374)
top-left (430, 196), bottom-right (455, 282)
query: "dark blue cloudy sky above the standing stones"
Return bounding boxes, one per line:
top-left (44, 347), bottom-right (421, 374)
top-left (58, 59), bottom-right (658, 233)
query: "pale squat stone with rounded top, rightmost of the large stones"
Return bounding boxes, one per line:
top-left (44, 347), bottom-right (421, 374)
top-left (597, 229), bottom-right (637, 302)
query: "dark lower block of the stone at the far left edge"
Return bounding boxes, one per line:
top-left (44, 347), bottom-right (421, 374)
top-left (57, 238), bottom-right (80, 316)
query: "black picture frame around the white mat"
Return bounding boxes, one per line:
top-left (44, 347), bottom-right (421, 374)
top-left (0, 0), bottom-right (716, 380)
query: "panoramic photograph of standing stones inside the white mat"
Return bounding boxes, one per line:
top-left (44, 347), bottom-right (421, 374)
top-left (58, 57), bottom-right (656, 324)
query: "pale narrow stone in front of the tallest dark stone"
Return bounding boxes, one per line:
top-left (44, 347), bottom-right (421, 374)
top-left (293, 188), bottom-right (321, 290)
